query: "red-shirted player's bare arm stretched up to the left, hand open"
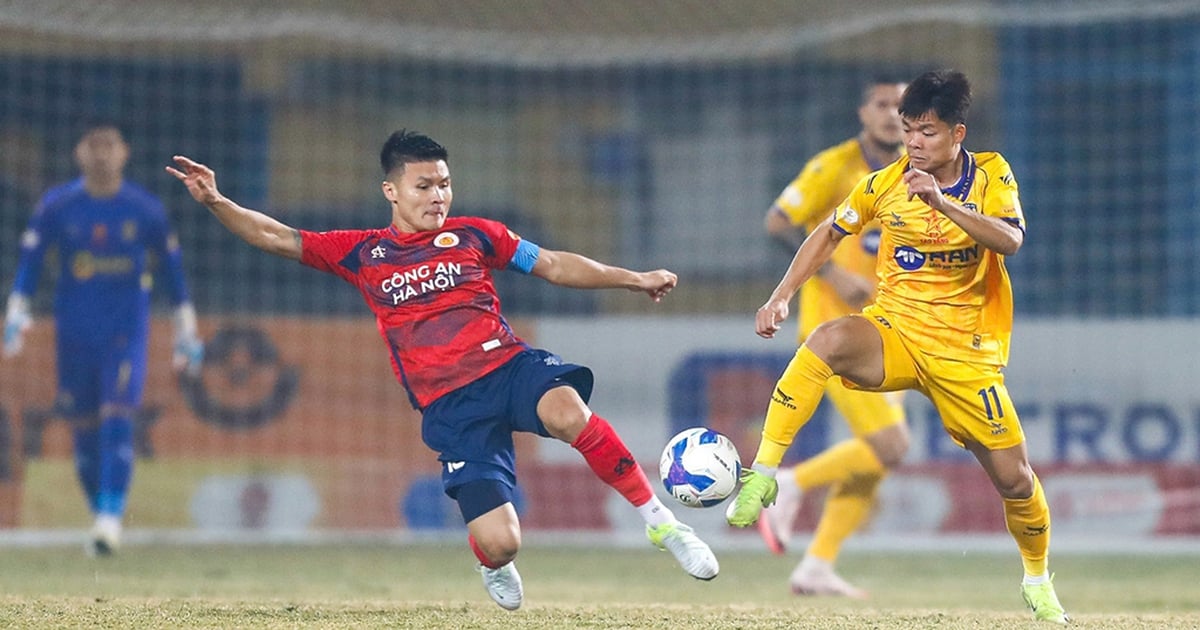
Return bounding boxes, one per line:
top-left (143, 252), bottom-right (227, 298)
top-left (167, 155), bottom-right (302, 260)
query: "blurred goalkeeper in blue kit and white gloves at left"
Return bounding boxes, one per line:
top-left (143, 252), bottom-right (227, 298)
top-left (4, 122), bottom-right (203, 556)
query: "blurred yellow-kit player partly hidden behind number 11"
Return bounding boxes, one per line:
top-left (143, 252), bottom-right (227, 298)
top-left (758, 79), bottom-right (908, 598)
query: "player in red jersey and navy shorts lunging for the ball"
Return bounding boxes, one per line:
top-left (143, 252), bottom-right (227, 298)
top-left (167, 126), bottom-right (719, 610)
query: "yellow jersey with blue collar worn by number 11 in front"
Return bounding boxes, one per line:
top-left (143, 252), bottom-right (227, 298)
top-left (834, 150), bottom-right (1025, 366)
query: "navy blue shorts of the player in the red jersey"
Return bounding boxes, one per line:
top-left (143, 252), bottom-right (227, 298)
top-left (421, 349), bottom-right (593, 499)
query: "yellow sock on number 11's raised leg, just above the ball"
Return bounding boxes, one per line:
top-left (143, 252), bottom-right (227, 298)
top-left (754, 346), bottom-right (833, 468)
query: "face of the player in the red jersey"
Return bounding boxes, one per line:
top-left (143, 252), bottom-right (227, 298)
top-left (383, 160), bottom-right (454, 232)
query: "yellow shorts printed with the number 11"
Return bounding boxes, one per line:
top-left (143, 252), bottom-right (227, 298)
top-left (842, 305), bottom-right (1025, 450)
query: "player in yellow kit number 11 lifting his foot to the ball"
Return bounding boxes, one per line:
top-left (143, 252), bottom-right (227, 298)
top-left (726, 71), bottom-right (1068, 623)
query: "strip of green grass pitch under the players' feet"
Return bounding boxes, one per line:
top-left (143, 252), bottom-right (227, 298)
top-left (0, 544), bottom-right (1200, 630)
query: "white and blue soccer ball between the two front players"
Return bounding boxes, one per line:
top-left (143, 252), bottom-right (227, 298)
top-left (659, 427), bottom-right (742, 508)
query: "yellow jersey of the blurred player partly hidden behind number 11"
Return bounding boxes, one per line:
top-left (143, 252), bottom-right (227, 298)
top-left (774, 138), bottom-right (880, 342)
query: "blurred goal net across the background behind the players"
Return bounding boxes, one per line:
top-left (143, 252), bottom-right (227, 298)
top-left (0, 0), bottom-right (1200, 544)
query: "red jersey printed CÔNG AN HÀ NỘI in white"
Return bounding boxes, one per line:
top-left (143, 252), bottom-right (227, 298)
top-left (300, 217), bottom-right (539, 409)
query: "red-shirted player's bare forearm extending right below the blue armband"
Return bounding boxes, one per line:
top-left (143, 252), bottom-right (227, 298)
top-left (533, 250), bottom-right (679, 301)
